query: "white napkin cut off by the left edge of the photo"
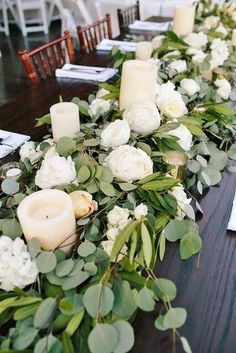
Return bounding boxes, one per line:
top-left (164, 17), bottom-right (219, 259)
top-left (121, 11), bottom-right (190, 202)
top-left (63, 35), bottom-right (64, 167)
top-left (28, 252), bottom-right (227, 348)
top-left (0, 130), bottom-right (30, 158)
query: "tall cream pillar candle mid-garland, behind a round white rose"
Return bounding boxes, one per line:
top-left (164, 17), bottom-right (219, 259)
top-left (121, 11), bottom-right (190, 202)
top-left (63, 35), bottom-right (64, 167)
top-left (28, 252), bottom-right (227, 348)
top-left (120, 60), bottom-right (157, 110)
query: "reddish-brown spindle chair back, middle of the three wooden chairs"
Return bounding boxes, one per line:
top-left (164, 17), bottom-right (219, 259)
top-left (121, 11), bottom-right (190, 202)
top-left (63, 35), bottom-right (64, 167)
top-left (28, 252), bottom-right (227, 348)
top-left (77, 14), bottom-right (112, 54)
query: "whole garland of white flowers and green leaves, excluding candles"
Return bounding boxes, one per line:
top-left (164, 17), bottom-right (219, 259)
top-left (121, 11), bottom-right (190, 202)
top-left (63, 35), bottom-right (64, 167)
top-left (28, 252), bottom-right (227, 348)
top-left (0, 2), bottom-right (236, 353)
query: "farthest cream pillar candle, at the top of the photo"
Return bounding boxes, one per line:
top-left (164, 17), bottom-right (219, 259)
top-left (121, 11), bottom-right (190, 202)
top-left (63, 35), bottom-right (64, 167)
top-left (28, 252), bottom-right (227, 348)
top-left (173, 5), bottom-right (195, 36)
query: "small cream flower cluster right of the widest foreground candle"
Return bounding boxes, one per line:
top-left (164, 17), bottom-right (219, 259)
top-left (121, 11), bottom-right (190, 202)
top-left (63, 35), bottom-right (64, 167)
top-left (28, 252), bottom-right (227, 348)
top-left (101, 203), bottom-right (148, 261)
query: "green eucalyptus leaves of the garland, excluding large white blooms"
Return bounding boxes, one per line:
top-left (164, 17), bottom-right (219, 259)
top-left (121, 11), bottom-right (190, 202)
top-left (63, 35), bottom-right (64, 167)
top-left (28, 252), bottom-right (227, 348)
top-left (0, 2), bottom-right (236, 353)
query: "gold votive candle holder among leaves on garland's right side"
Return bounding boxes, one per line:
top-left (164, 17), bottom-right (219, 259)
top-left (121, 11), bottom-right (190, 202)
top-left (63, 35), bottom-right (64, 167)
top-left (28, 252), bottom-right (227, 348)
top-left (162, 151), bottom-right (188, 181)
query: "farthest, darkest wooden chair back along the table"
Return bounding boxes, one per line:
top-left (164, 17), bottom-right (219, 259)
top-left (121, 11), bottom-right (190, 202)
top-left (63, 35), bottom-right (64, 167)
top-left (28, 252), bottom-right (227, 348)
top-left (117, 1), bottom-right (140, 34)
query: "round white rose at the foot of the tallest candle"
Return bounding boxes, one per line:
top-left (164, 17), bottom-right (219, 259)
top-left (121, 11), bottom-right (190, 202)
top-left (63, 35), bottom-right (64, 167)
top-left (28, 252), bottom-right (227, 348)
top-left (123, 102), bottom-right (161, 135)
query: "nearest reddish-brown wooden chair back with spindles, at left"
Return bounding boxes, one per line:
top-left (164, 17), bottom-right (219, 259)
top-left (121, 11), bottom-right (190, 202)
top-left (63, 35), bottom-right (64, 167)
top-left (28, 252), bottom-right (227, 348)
top-left (18, 31), bottom-right (75, 85)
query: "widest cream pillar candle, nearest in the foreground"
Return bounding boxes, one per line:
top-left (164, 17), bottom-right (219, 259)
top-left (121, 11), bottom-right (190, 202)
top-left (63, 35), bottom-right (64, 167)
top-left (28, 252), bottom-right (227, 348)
top-left (17, 190), bottom-right (76, 251)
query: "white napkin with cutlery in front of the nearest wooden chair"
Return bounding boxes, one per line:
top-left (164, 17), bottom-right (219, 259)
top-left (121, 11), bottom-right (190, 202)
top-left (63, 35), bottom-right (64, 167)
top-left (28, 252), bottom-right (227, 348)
top-left (56, 64), bottom-right (117, 82)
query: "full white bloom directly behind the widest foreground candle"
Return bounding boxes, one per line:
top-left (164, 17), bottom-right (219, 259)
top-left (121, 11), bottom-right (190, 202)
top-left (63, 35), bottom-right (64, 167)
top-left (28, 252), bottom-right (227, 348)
top-left (35, 154), bottom-right (76, 189)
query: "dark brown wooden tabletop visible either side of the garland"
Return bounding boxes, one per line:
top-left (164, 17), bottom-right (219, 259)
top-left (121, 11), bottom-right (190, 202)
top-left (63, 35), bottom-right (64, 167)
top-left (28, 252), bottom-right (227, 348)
top-left (0, 20), bottom-right (236, 353)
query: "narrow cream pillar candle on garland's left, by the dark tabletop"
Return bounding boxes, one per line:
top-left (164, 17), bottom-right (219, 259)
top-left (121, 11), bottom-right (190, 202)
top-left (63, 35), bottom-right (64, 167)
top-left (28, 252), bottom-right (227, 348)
top-left (50, 102), bottom-right (80, 142)
